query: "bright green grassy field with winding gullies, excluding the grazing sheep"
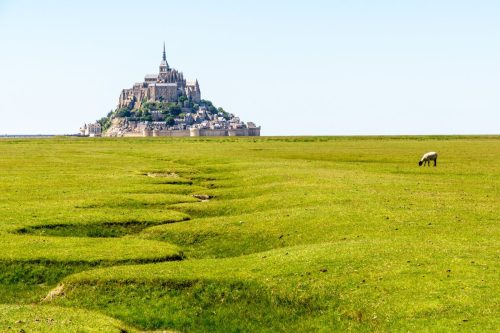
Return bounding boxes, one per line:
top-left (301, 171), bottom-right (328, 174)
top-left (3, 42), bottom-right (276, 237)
top-left (0, 136), bottom-right (500, 332)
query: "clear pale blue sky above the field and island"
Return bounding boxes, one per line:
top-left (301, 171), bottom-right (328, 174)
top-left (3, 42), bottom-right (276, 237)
top-left (0, 0), bottom-right (500, 135)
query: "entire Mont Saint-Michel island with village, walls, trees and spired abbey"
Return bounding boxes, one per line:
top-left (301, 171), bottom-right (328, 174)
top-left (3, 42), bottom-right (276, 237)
top-left (80, 44), bottom-right (260, 137)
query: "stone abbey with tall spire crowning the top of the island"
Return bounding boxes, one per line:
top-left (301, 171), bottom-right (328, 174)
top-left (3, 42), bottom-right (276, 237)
top-left (118, 44), bottom-right (201, 109)
